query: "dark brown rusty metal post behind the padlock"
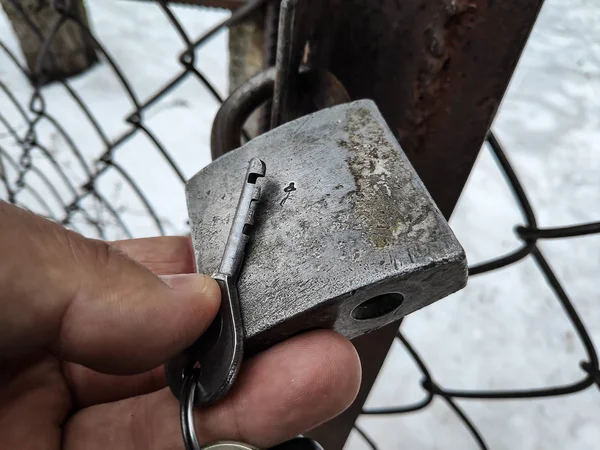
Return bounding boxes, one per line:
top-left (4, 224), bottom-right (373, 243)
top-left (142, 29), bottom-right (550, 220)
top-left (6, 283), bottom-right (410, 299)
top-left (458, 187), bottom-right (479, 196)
top-left (310, 0), bottom-right (543, 450)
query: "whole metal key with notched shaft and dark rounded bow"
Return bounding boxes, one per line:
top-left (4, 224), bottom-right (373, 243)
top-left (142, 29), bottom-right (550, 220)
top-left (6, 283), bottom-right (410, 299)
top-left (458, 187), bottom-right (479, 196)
top-left (166, 158), bottom-right (266, 408)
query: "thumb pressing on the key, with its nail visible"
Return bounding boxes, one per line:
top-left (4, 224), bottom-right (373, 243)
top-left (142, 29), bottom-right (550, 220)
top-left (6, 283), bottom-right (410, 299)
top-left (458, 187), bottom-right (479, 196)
top-left (0, 202), bottom-right (220, 374)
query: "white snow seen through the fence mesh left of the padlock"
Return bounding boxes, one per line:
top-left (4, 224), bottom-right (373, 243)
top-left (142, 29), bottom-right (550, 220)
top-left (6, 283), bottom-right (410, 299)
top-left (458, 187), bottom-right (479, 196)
top-left (0, 1), bottom-right (227, 239)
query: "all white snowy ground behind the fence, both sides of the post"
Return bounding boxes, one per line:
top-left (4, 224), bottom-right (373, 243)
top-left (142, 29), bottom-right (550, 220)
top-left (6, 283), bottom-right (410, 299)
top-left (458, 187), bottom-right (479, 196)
top-left (0, 0), bottom-right (600, 450)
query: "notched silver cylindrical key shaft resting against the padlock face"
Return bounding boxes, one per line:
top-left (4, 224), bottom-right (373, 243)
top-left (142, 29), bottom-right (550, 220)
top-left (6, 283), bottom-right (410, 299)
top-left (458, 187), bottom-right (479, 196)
top-left (219, 158), bottom-right (266, 277)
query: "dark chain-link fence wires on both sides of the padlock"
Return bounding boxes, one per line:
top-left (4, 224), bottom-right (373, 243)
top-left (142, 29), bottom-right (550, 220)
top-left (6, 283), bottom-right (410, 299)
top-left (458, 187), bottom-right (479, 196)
top-left (0, 0), bottom-right (600, 449)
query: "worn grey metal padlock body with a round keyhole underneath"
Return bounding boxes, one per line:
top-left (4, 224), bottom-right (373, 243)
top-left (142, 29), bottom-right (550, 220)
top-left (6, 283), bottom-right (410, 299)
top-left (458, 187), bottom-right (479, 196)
top-left (186, 100), bottom-right (467, 355)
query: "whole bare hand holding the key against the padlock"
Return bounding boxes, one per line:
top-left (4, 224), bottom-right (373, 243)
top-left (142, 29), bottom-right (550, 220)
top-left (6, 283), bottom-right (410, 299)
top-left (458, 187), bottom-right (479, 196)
top-left (0, 202), bottom-right (360, 450)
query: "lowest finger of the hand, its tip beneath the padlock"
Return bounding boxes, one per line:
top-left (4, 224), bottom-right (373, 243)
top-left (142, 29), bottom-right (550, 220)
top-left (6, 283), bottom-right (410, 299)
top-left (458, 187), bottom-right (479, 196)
top-left (65, 331), bottom-right (360, 450)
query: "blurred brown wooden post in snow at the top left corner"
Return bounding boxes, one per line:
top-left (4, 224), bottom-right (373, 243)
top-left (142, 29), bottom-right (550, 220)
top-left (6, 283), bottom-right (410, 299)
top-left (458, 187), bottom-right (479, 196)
top-left (0, 0), bottom-right (98, 84)
